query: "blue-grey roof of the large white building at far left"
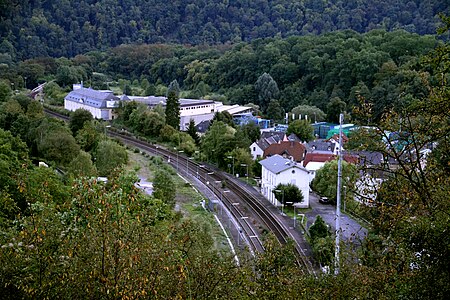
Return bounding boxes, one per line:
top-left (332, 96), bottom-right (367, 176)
top-left (64, 88), bottom-right (119, 108)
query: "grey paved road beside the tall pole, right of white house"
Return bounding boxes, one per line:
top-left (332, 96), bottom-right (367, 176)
top-left (305, 193), bottom-right (367, 243)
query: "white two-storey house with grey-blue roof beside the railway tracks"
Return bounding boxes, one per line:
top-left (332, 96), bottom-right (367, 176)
top-left (259, 154), bottom-right (309, 208)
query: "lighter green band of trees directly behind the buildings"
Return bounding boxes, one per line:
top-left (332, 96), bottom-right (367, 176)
top-left (0, 29), bottom-right (439, 122)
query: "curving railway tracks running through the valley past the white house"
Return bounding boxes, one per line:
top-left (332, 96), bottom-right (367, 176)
top-left (45, 109), bottom-right (315, 274)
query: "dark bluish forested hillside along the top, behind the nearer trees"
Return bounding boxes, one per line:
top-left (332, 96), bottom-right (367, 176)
top-left (0, 0), bottom-right (449, 59)
